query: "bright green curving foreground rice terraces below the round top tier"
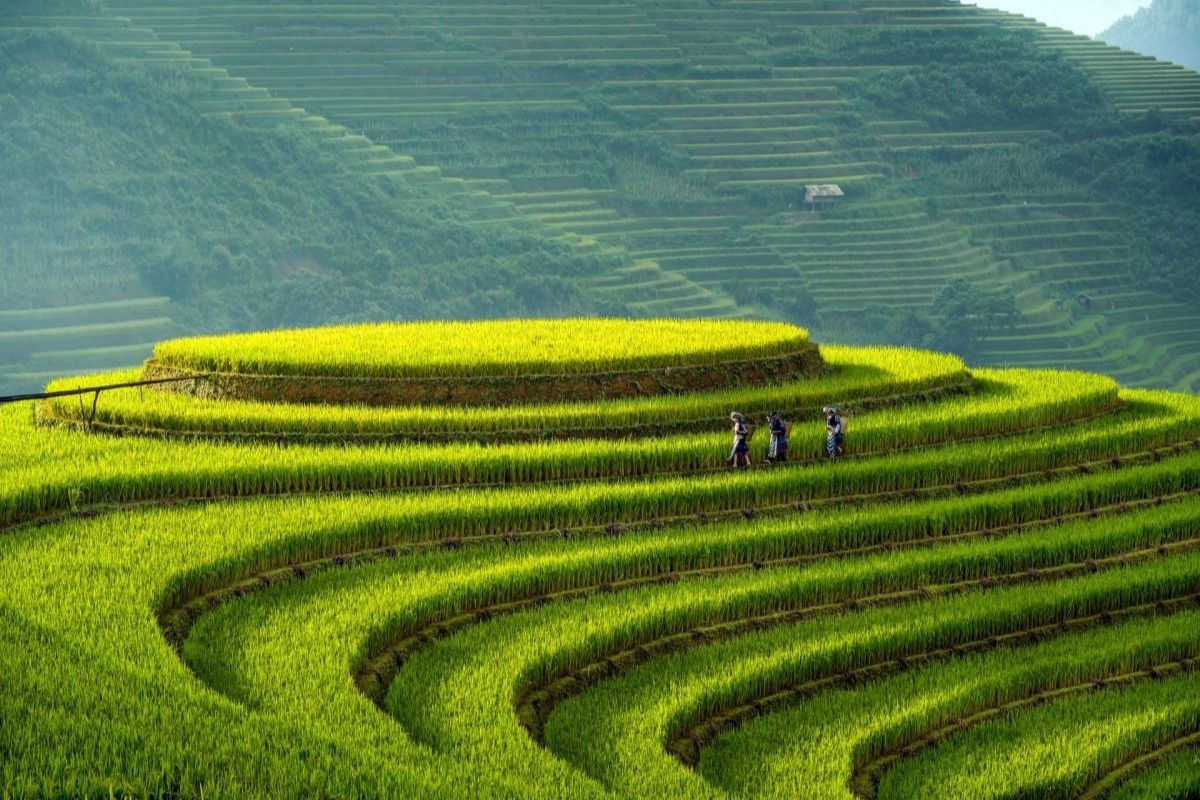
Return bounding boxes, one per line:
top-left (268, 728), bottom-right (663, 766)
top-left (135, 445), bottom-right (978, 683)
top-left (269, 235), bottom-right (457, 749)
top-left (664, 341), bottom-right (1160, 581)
top-left (7, 323), bottom-right (1200, 798)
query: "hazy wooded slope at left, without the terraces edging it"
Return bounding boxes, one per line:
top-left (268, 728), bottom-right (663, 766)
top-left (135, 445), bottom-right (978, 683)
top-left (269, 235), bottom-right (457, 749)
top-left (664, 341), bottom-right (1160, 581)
top-left (0, 32), bottom-right (614, 327)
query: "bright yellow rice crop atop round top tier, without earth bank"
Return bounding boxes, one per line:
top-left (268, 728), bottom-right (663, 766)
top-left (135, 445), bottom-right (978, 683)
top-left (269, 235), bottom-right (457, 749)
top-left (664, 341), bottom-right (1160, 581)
top-left (147, 319), bottom-right (809, 378)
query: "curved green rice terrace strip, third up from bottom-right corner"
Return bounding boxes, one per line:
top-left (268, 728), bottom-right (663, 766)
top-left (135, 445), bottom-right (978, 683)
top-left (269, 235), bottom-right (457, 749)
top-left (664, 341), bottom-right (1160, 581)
top-left (698, 612), bottom-right (1200, 800)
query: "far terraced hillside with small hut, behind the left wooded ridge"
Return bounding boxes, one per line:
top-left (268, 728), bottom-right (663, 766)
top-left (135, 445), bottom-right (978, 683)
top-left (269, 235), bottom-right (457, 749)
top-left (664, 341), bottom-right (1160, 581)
top-left (88, 0), bottom-right (1200, 387)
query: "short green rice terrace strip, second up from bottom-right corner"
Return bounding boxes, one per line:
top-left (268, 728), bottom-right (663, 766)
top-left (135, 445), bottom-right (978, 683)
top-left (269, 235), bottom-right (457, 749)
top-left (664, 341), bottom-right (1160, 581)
top-left (878, 672), bottom-right (1200, 799)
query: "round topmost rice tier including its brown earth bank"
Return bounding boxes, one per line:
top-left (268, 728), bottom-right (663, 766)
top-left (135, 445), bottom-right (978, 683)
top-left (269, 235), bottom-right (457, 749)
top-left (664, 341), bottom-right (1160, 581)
top-left (138, 319), bottom-right (824, 407)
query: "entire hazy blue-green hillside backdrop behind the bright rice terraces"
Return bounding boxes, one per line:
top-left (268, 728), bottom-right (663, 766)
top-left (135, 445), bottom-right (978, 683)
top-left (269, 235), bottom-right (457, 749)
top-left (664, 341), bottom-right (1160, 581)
top-left (0, 0), bottom-right (1200, 389)
